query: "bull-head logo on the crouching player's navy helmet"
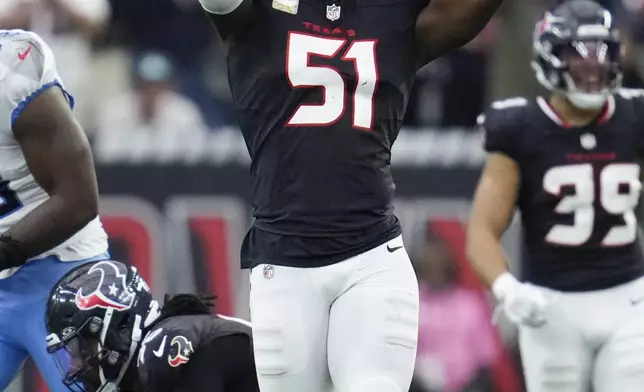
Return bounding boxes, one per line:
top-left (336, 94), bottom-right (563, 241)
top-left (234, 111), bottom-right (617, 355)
top-left (76, 261), bottom-right (134, 311)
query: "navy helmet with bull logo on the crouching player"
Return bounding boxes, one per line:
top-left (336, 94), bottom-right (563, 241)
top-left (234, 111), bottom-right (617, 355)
top-left (45, 260), bottom-right (160, 392)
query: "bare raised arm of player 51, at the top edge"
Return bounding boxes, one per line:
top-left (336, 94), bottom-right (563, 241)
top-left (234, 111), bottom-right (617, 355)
top-left (416, 0), bottom-right (503, 63)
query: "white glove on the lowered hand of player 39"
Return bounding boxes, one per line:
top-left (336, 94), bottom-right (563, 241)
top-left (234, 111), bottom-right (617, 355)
top-left (492, 272), bottom-right (547, 328)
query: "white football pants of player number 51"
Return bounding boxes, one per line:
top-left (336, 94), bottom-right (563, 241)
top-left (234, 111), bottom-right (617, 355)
top-left (250, 237), bottom-right (418, 392)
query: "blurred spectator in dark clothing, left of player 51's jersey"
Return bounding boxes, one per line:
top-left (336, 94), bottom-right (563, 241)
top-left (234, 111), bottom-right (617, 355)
top-left (110, 0), bottom-right (232, 127)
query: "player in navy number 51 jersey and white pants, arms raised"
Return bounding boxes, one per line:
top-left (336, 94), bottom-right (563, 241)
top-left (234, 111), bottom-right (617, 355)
top-left (195, 0), bottom-right (502, 392)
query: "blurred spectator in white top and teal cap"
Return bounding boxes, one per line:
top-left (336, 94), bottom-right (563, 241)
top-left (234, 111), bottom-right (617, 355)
top-left (96, 52), bottom-right (206, 144)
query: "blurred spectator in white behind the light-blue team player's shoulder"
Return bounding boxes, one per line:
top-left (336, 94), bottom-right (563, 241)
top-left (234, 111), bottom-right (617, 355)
top-left (0, 0), bottom-right (110, 127)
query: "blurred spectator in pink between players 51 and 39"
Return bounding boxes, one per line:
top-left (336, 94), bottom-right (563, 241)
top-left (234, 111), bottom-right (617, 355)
top-left (414, 232), bottom-right (500, 392)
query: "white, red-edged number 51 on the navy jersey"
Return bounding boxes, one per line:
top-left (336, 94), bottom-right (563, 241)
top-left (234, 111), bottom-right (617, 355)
top-left (286, 33), bottom-right (378, 129)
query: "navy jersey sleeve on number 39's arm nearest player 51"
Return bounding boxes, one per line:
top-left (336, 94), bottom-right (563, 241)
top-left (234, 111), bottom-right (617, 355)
top-left (477, 97), bottom-right (528, 162)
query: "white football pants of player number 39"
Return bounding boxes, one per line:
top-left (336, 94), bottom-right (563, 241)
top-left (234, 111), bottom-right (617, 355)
top-left (519, 278), bottom-right (644, 392)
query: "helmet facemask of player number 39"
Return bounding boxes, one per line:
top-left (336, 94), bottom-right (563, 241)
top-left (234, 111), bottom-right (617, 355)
top-left (532, 16), bottom-right (622, 110)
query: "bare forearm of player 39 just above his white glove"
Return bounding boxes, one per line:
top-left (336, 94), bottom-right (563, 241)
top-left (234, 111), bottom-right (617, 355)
top-left (467, 229), bottom-right (508, 286)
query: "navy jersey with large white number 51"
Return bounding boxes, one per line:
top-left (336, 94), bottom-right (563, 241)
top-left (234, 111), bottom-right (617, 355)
top-left (212, 0), bottom-right (427, 267)
